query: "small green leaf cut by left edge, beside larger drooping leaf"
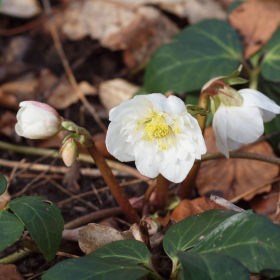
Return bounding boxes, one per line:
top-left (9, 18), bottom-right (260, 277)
top-left (0, 210), bottom-right (24, 251)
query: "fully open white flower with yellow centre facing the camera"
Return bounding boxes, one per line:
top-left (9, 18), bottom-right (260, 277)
top-left (106, 93), bottom-right (206, 183)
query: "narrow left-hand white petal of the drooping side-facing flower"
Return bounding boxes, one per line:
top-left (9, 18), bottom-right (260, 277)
top-left (213, 106), bottom-right (229, 158)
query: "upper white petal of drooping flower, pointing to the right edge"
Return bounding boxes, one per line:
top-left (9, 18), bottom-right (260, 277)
top-left (238, 89), bottom-right (280, 114)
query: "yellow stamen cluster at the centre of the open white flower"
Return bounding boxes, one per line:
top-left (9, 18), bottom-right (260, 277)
top-left (137, 112), bottom-right (181, 150)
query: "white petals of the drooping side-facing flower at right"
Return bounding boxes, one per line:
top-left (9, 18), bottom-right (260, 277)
top-left (213, 89), bottom-right (280, 158)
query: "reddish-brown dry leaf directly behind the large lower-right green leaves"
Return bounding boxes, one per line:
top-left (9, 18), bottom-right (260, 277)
top-left (159, 197), bottom-right (225, 226)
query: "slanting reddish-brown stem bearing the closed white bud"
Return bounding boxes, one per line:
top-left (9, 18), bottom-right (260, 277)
top-left (88, 142), bottom-right (140, 223)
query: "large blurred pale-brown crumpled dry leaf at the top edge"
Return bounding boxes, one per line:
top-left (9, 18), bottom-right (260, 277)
top-left (62, 0), bottom-right (179, 68)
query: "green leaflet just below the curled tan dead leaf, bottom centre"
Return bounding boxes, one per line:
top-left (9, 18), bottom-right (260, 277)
top-left (87, 240), bottom-right (150, 266)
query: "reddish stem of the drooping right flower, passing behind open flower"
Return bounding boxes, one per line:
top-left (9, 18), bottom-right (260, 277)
top-left (178, 93), bottom-right (209, 199)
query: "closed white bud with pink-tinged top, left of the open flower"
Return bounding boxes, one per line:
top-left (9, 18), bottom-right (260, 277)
top-left (15, 101), bottom-right (62, 139)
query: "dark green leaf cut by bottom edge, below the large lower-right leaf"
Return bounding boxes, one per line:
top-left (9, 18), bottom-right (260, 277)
top-left (177, 251), bottom-right (250, 280)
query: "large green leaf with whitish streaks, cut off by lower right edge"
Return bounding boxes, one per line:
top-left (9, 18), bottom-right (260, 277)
top-left (192, 210), bottom-right (280, 275)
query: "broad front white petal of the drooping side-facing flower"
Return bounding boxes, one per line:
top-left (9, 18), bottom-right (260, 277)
top-left (226, 106), bottom-right (264, 143)
